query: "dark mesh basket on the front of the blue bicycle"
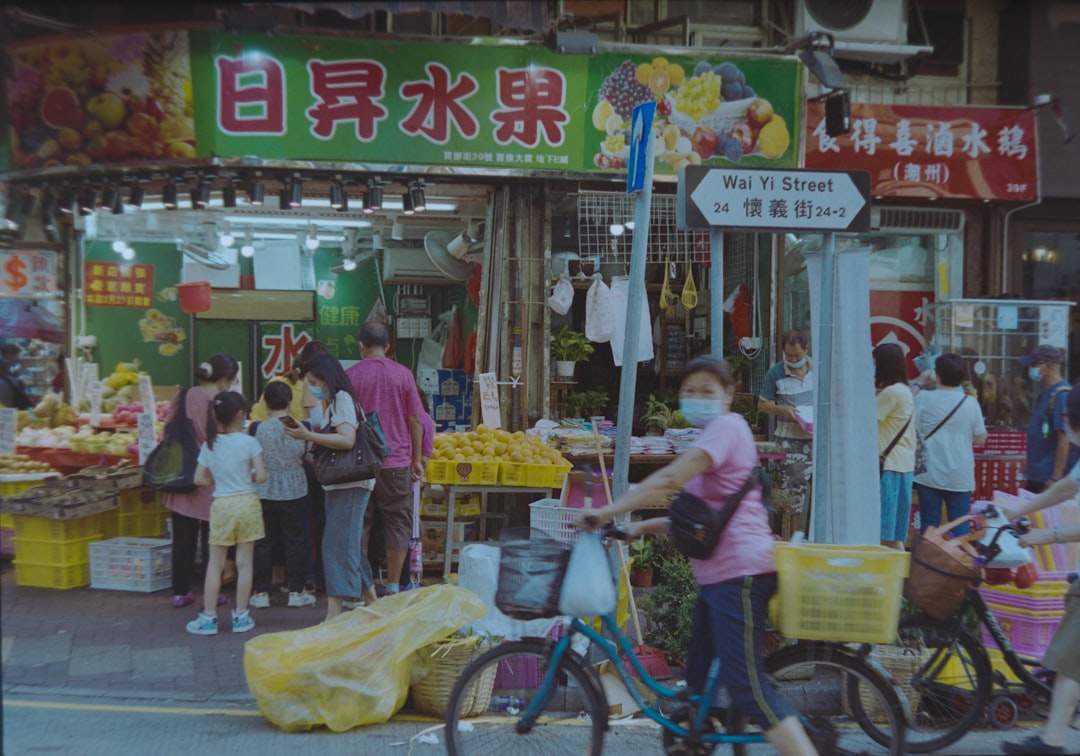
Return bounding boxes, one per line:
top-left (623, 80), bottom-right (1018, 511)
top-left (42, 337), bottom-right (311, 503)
top-left (495, 527), bottom-right (570, 620)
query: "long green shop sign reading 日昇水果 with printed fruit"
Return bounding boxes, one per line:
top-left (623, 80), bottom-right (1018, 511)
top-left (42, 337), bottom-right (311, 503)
top-left (190, 32), bottom-right (800, 174)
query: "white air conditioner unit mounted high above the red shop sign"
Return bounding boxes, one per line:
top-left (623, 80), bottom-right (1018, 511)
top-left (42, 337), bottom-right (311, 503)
top-left (795, 0), bottom-right (933, 63)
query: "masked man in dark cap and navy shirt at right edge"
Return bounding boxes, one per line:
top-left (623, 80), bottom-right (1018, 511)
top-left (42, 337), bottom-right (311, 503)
top-left (1020, 343), bottom-right (1080, 494)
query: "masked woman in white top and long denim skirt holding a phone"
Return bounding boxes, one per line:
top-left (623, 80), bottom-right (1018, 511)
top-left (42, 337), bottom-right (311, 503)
top-left (285, 354), bottom-right (376, 621)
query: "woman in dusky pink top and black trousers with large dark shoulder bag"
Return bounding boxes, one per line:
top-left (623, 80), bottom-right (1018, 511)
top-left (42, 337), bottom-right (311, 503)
top-left (164, 352), bottom-right (240, 609)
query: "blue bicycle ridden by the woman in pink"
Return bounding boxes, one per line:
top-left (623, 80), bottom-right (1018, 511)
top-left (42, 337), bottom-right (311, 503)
top-left (445, 527), bottom-right (907, 756)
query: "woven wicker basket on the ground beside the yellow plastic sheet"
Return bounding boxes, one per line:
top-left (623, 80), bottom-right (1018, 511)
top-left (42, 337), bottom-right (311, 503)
top-left (410, 637), bottom-right (497, 717)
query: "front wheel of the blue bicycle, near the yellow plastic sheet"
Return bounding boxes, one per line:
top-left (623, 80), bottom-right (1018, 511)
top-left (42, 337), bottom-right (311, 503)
top-left (446, 639), bottom-right (608, 756)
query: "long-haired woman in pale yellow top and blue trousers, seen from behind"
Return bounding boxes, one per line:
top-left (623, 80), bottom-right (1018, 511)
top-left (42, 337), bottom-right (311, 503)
top-left (874, 343), bottom-right (915, 551)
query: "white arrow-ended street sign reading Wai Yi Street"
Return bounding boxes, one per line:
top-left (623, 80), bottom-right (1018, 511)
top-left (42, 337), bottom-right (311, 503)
top-left (678, 165), bottom-right (870, 231)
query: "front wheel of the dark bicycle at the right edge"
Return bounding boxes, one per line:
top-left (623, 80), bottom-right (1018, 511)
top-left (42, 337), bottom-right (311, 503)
top-left (853, 615), bottom-right (993, 754)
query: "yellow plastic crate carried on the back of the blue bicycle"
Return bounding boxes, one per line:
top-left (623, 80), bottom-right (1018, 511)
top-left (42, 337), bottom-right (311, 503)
top-left (775, 543), bottom-right (909, 643)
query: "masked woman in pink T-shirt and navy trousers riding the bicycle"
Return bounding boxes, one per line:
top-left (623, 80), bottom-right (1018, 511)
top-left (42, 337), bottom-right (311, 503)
top-left (578, 356), bottom-right (815, 755)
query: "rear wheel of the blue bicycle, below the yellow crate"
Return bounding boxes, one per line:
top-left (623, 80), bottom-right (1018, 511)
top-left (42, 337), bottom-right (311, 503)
top-left (766, 642), bottom-right (905, 756)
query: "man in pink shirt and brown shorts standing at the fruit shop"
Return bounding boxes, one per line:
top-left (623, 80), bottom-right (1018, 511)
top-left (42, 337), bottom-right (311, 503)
top-left (346, 322), bottom-right (423, 594)
